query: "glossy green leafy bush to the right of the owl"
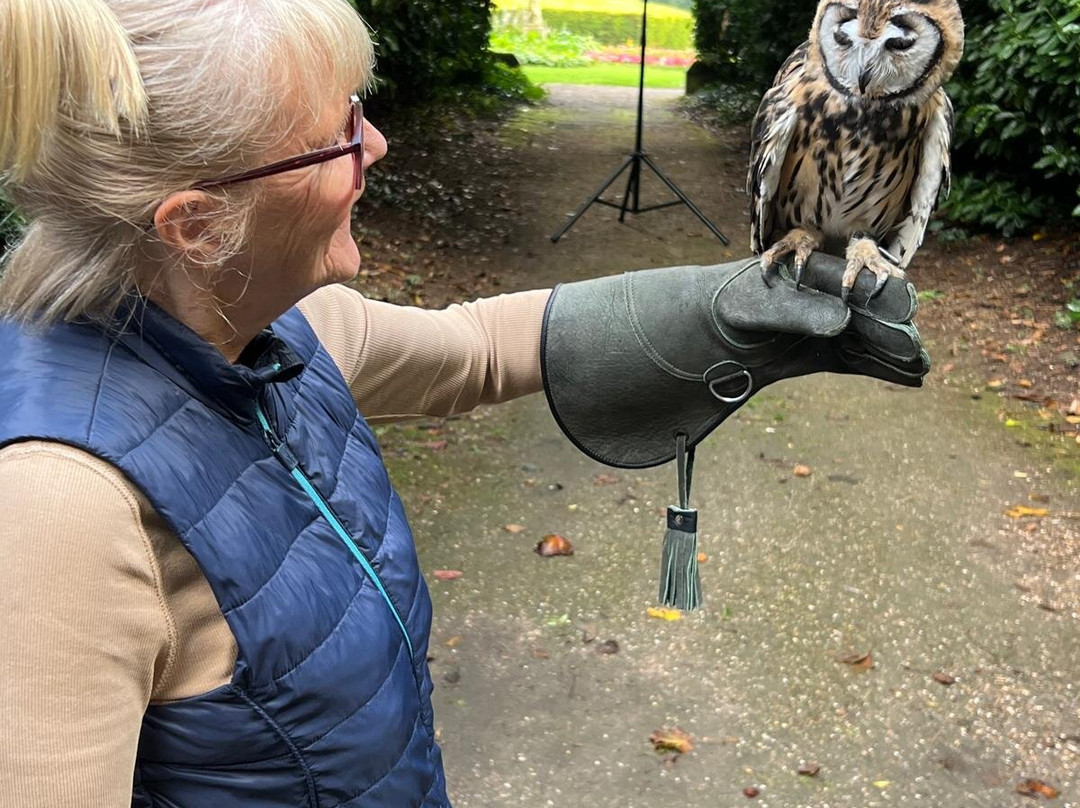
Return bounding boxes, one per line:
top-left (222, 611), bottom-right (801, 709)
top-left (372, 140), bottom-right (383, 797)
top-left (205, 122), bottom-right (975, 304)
top-left (943, 0), bottom-right (1080, 234)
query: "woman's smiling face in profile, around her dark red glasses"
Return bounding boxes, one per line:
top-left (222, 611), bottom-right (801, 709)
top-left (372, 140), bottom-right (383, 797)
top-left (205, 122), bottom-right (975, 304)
top-left (238, 93), bottom-right (387, 311)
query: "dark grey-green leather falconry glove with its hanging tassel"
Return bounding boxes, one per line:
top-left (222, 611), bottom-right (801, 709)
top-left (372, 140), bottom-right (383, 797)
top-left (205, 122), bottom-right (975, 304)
top-left (541, 253), bottom-right (930, 609)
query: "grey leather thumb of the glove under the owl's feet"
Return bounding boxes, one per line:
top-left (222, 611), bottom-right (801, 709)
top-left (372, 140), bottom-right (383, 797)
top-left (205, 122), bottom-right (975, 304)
top-left (713, 259), bottom-right (850, 342)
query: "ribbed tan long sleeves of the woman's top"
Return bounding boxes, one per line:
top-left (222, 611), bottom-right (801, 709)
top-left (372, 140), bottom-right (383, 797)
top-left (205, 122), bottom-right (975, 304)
top-left (0, 286), bottom-right (549, 808)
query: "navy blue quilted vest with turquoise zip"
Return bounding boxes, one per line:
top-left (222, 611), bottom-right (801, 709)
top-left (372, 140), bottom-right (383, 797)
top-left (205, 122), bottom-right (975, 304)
top-left (0, 306), bottom-right (448, 808)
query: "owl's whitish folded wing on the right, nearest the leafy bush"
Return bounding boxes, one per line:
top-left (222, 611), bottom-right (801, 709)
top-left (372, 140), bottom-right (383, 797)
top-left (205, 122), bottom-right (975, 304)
top-left (889, 89), bottom-right (953, 269)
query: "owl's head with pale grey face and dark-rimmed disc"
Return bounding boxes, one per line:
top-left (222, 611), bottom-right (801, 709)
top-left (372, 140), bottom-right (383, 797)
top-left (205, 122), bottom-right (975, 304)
top-left (809, 0), bottom-right (963, 104)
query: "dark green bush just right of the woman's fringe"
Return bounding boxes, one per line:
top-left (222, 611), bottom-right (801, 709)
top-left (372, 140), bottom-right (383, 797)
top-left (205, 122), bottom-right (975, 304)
top-left (351, 0), bottom-right (490, 103)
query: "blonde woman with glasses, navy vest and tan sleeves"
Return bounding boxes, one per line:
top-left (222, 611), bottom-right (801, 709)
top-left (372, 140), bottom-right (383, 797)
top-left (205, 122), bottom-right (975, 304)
top-left (0, 0), bottom-right (926, 808)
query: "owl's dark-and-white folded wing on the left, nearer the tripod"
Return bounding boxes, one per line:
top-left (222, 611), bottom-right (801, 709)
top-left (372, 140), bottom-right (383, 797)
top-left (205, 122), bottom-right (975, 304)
top-left (746, 42), bottom-right (809, 254)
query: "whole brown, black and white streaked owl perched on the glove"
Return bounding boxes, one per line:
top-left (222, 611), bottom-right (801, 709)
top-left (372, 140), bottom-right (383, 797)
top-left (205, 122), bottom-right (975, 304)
top-left (746, 0), bottom-right (963, 298)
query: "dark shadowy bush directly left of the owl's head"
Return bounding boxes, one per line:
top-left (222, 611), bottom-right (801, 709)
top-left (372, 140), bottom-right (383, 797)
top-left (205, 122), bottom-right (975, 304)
top-left (693, 0), bottom-right (814, 93)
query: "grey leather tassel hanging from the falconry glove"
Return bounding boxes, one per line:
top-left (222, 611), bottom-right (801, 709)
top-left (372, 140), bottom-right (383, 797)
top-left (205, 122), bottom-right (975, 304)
top-left (660, 433), bottom-right (703, 611)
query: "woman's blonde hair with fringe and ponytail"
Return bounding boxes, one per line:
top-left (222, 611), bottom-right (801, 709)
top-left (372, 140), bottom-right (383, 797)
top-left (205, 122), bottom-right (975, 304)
top-left (0, 0), bottom-right (374, 322)
